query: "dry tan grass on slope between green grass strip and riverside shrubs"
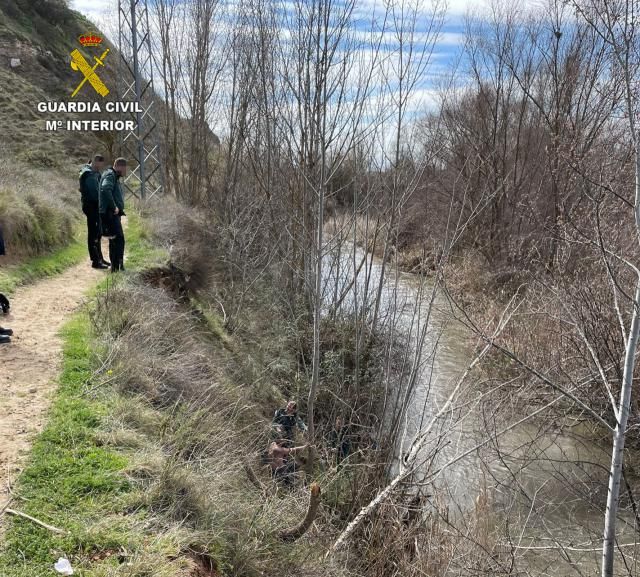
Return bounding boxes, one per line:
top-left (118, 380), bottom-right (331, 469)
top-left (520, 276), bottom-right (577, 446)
top-left (85, 282), bottom-right (356, 577)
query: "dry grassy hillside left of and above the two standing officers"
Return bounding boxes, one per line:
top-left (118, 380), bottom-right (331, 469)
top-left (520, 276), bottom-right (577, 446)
top-left (0, 0), bottom-right (112, 259)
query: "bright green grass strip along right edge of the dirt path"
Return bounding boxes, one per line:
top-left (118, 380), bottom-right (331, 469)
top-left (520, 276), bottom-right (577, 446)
top-left (0, 314), bottom-right (130, 577)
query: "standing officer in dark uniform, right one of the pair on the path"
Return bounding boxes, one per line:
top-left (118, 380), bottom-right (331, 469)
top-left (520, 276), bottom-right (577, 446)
top-left (100, 158), bottom-right (127, 272)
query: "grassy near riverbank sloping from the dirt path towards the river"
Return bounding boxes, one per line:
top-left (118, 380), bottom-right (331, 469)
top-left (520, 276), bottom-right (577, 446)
top-left (0, 209), bottom-right (390, 577)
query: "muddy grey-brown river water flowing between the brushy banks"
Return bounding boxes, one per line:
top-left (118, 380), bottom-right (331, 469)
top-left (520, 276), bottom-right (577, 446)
top-left (325, 244), bottom-right (640, 577)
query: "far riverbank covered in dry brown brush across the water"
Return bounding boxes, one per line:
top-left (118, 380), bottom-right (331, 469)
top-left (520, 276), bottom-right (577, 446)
top-left (340, 214), bottom-right (624, 424)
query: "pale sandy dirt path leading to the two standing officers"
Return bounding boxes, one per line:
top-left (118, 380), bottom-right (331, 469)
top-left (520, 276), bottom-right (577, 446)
top-left (0, 262), bottom-right (105, 508)
